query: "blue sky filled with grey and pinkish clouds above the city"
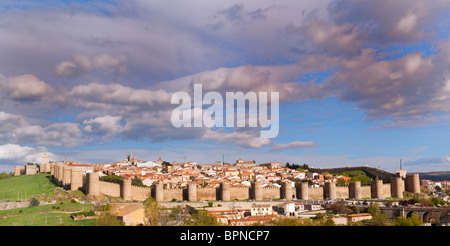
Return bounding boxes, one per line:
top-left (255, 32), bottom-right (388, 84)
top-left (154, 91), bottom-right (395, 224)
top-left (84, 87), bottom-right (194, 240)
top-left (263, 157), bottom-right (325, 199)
top-left (0, 0), bottom-right (450, 172)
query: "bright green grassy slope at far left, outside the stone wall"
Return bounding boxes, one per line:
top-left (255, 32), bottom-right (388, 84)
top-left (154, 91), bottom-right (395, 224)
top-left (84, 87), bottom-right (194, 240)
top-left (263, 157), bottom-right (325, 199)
top-left (0, 174), bottom-right (56, 201)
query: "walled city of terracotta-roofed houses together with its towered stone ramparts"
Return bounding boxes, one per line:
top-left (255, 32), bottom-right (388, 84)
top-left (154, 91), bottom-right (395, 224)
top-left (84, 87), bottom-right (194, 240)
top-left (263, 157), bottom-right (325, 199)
top-left (15, 154), bottom-right (420, 202)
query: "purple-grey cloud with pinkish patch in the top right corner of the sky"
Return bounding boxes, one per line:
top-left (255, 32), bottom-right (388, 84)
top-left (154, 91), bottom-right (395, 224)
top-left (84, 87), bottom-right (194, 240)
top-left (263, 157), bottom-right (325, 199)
top-left (328, 0), bottom-right (450, 45)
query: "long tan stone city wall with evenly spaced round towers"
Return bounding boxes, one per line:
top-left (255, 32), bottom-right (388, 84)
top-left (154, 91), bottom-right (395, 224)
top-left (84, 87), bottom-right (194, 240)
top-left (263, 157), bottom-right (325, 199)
top-left (46, 163), bottom-right (420, 202)
